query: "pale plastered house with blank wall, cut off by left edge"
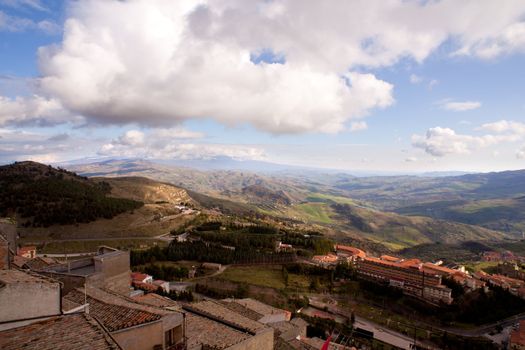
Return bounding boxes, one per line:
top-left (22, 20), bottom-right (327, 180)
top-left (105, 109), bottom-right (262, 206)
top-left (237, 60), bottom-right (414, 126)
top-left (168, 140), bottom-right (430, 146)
top-left (0, 270), bottom-right (61, 330)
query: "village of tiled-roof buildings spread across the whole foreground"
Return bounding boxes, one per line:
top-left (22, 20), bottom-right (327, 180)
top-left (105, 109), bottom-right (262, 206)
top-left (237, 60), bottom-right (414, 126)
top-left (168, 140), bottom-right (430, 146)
top-left (0, 220), bottom-right (525, 350)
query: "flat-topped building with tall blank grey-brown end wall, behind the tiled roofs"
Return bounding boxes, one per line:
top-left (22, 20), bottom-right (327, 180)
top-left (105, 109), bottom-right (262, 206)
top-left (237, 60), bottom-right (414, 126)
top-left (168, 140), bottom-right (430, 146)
top-left (38, 246), bottom-right (131, 295)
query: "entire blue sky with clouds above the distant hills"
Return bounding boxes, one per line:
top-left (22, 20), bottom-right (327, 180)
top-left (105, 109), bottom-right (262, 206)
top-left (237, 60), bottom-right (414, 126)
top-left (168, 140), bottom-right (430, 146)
top-left (0, 0), bottom-right (525, 173)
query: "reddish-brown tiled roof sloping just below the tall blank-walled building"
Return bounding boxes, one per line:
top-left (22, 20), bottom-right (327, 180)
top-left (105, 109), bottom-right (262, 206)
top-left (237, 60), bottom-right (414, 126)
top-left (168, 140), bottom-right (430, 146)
top-left (64, 290), bottom-right (161, 332)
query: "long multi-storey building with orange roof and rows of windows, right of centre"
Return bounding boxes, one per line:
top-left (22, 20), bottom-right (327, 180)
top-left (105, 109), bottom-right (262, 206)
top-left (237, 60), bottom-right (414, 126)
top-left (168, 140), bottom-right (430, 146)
top-left (357, 255), bottom-right (452, 304)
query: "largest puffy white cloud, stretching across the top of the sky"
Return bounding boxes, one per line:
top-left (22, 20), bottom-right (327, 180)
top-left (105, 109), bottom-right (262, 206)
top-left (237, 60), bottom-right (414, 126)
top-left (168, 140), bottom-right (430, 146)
top-left (30, 0), bottom-right (525, 133)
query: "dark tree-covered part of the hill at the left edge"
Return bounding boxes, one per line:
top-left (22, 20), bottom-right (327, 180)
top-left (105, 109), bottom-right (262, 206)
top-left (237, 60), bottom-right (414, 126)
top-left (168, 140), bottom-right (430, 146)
top-left (0, 162), bottom-right (143, 227)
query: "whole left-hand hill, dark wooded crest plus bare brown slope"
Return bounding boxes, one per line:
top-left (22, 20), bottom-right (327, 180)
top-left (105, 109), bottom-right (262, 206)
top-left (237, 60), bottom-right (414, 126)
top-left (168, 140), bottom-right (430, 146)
top-left (0, 162), bottom-right (198, 240)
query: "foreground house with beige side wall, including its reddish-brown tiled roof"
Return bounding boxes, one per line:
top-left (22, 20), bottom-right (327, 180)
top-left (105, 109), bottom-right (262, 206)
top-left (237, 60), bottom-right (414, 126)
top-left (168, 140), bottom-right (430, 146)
top-left (63, 287), bottom-right (184, 350)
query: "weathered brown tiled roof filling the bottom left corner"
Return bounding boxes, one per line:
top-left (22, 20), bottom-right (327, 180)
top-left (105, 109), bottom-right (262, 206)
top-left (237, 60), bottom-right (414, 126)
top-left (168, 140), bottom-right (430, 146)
top-left (0, 314), bottom-right (121, 350)
